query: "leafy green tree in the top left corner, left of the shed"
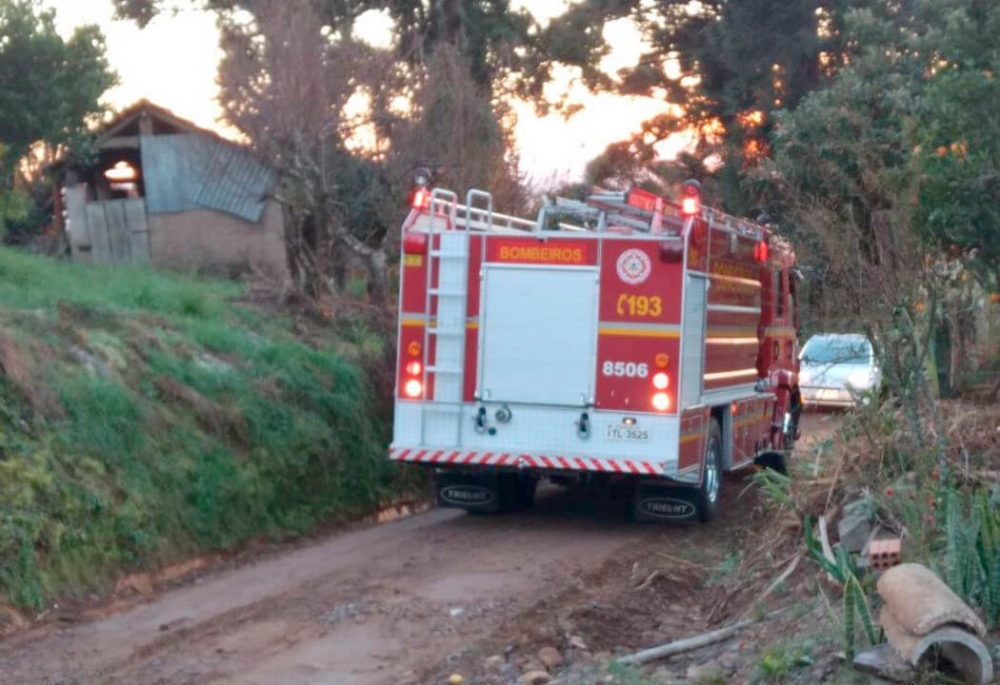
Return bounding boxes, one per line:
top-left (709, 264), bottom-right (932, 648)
top-left (0, 0), bottom-right (116, 232)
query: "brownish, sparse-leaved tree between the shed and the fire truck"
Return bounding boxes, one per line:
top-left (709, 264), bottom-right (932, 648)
top-left (220, 2), bottom-right (520, 305)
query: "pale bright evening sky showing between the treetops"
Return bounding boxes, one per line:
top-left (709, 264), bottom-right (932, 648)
top-left (43, 0), bottom-right (684, 184)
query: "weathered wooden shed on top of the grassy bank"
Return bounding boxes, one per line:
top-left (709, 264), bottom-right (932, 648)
top-left (56, 100), bottom-right (288, 276)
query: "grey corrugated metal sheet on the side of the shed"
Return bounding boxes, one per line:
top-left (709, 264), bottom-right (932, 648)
top-left (140, 134), bottom-right (275, 222)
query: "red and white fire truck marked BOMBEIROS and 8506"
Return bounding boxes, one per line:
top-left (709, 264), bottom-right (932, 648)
top-left (389, 179), bottom-right (802, 522)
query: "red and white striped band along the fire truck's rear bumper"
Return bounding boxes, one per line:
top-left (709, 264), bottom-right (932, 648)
top-left (389, 448), bottom-right (667, 476)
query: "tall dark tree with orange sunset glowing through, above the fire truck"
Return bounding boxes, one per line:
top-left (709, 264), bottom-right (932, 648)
top-left (556, 0), bottom-right (867, 214)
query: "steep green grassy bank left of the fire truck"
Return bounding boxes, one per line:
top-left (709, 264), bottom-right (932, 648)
top-left (0, 249), bottom-right (413, 608)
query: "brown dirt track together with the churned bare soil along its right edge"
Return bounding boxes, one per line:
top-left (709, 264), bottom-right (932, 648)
top-left (0, 417), bottom-right (844, 685)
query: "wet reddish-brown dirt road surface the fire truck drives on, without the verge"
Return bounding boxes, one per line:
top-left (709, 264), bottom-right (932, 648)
top-left (0, 408), bottom-right (829, 685)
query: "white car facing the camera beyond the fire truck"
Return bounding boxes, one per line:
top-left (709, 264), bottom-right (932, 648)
top-left (799, 333), bottom-right (882, 407)
